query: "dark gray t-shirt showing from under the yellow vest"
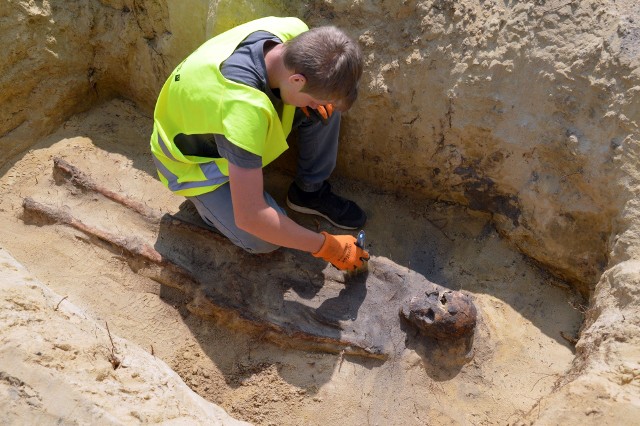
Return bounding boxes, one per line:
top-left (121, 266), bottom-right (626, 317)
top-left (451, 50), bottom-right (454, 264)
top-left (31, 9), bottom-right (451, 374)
top-left (214, 31), bottom-right (283, 169)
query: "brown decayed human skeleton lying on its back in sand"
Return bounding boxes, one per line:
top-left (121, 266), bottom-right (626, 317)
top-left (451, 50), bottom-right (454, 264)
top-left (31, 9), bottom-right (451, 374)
top-left (31, 159), bottom-right (476, 359)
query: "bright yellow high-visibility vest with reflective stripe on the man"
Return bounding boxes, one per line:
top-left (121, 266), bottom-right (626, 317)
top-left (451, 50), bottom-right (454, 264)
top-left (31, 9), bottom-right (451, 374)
top-left (151, 17), bottom-right (308, 197)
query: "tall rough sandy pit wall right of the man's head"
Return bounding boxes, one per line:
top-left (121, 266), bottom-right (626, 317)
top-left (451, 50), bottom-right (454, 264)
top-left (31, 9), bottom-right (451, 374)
top-left (310, 1), bottom-right (640, 292)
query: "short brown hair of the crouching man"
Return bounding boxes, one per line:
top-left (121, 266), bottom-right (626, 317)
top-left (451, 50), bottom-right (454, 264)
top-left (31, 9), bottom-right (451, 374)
top-left (284, 26), bottom-right (363, 110)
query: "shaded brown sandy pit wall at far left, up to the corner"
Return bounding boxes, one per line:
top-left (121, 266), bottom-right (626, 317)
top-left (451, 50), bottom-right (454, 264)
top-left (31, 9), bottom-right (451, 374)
top-left (0, 1), bottom-right (95, 156)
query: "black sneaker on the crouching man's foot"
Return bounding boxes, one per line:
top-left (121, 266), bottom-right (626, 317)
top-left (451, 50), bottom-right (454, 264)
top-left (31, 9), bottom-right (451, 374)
top-left (287, 181), bottom-right (367, 229)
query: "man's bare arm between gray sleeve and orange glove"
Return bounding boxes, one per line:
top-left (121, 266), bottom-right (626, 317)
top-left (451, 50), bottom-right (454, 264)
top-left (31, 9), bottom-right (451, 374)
top-left (229, 163), bottom-right (325, 253)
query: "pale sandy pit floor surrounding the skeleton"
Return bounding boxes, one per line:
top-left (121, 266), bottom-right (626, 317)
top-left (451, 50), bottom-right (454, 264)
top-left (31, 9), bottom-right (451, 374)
top-left (0, 100), bottom-right (585, 425)
